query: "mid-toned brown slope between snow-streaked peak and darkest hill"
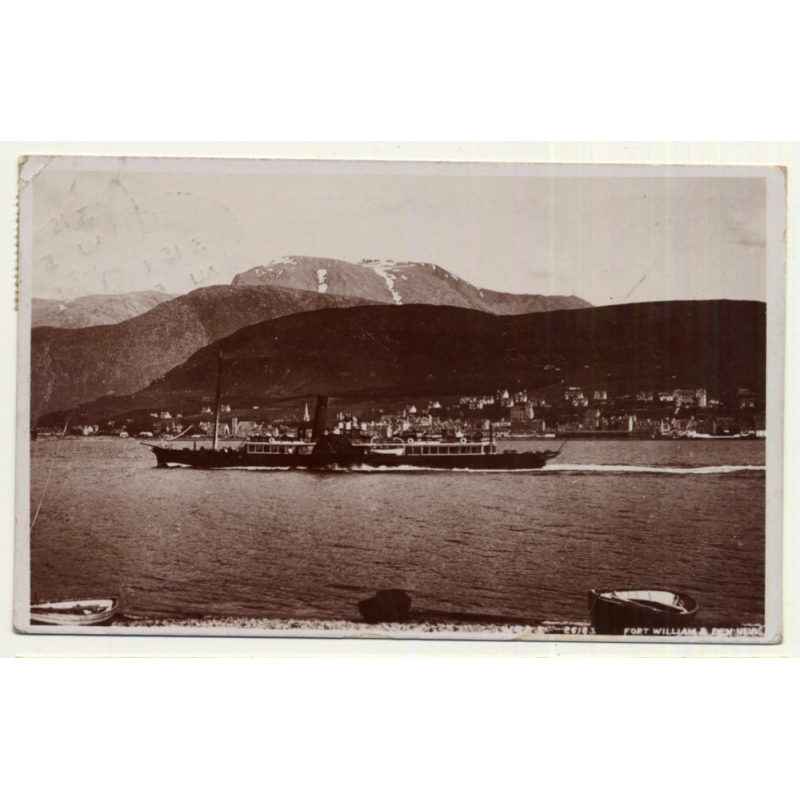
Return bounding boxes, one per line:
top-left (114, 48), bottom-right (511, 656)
top-left (31, 286), bottom-right (378, 419)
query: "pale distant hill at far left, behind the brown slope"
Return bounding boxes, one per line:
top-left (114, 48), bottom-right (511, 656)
top-left (31, 292), bottom-right (174, 328)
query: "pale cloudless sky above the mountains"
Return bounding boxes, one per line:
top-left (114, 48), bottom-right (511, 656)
top-left (32, 159), bottom-right (766, 305)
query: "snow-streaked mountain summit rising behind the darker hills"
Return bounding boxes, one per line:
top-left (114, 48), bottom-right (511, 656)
top-left (228, 256), bottom-right (590, 314)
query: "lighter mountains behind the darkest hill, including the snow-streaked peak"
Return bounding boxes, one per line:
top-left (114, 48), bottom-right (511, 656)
top-left (31, 256), bottom-right (588, 418)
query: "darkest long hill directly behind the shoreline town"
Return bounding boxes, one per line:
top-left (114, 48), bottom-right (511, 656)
top-left (61, 301), bottom-right (766, 422)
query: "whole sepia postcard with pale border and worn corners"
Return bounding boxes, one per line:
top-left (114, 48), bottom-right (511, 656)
top-left (14, 156), bottom-right (786, 643)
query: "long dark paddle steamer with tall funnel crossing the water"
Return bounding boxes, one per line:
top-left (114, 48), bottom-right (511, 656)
top-left (143, 395), bottom-right (558, 471)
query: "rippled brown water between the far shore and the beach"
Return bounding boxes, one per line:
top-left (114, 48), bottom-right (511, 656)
top-left (31, 438), bottom-right (765, 625)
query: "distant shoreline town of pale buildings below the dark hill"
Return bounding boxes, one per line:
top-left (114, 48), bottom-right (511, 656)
top-left (32, 386), bottom-right (766, 440)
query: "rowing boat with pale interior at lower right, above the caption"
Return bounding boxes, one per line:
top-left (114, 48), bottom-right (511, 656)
top-left (589, 589), bottom-right (699, 635)
